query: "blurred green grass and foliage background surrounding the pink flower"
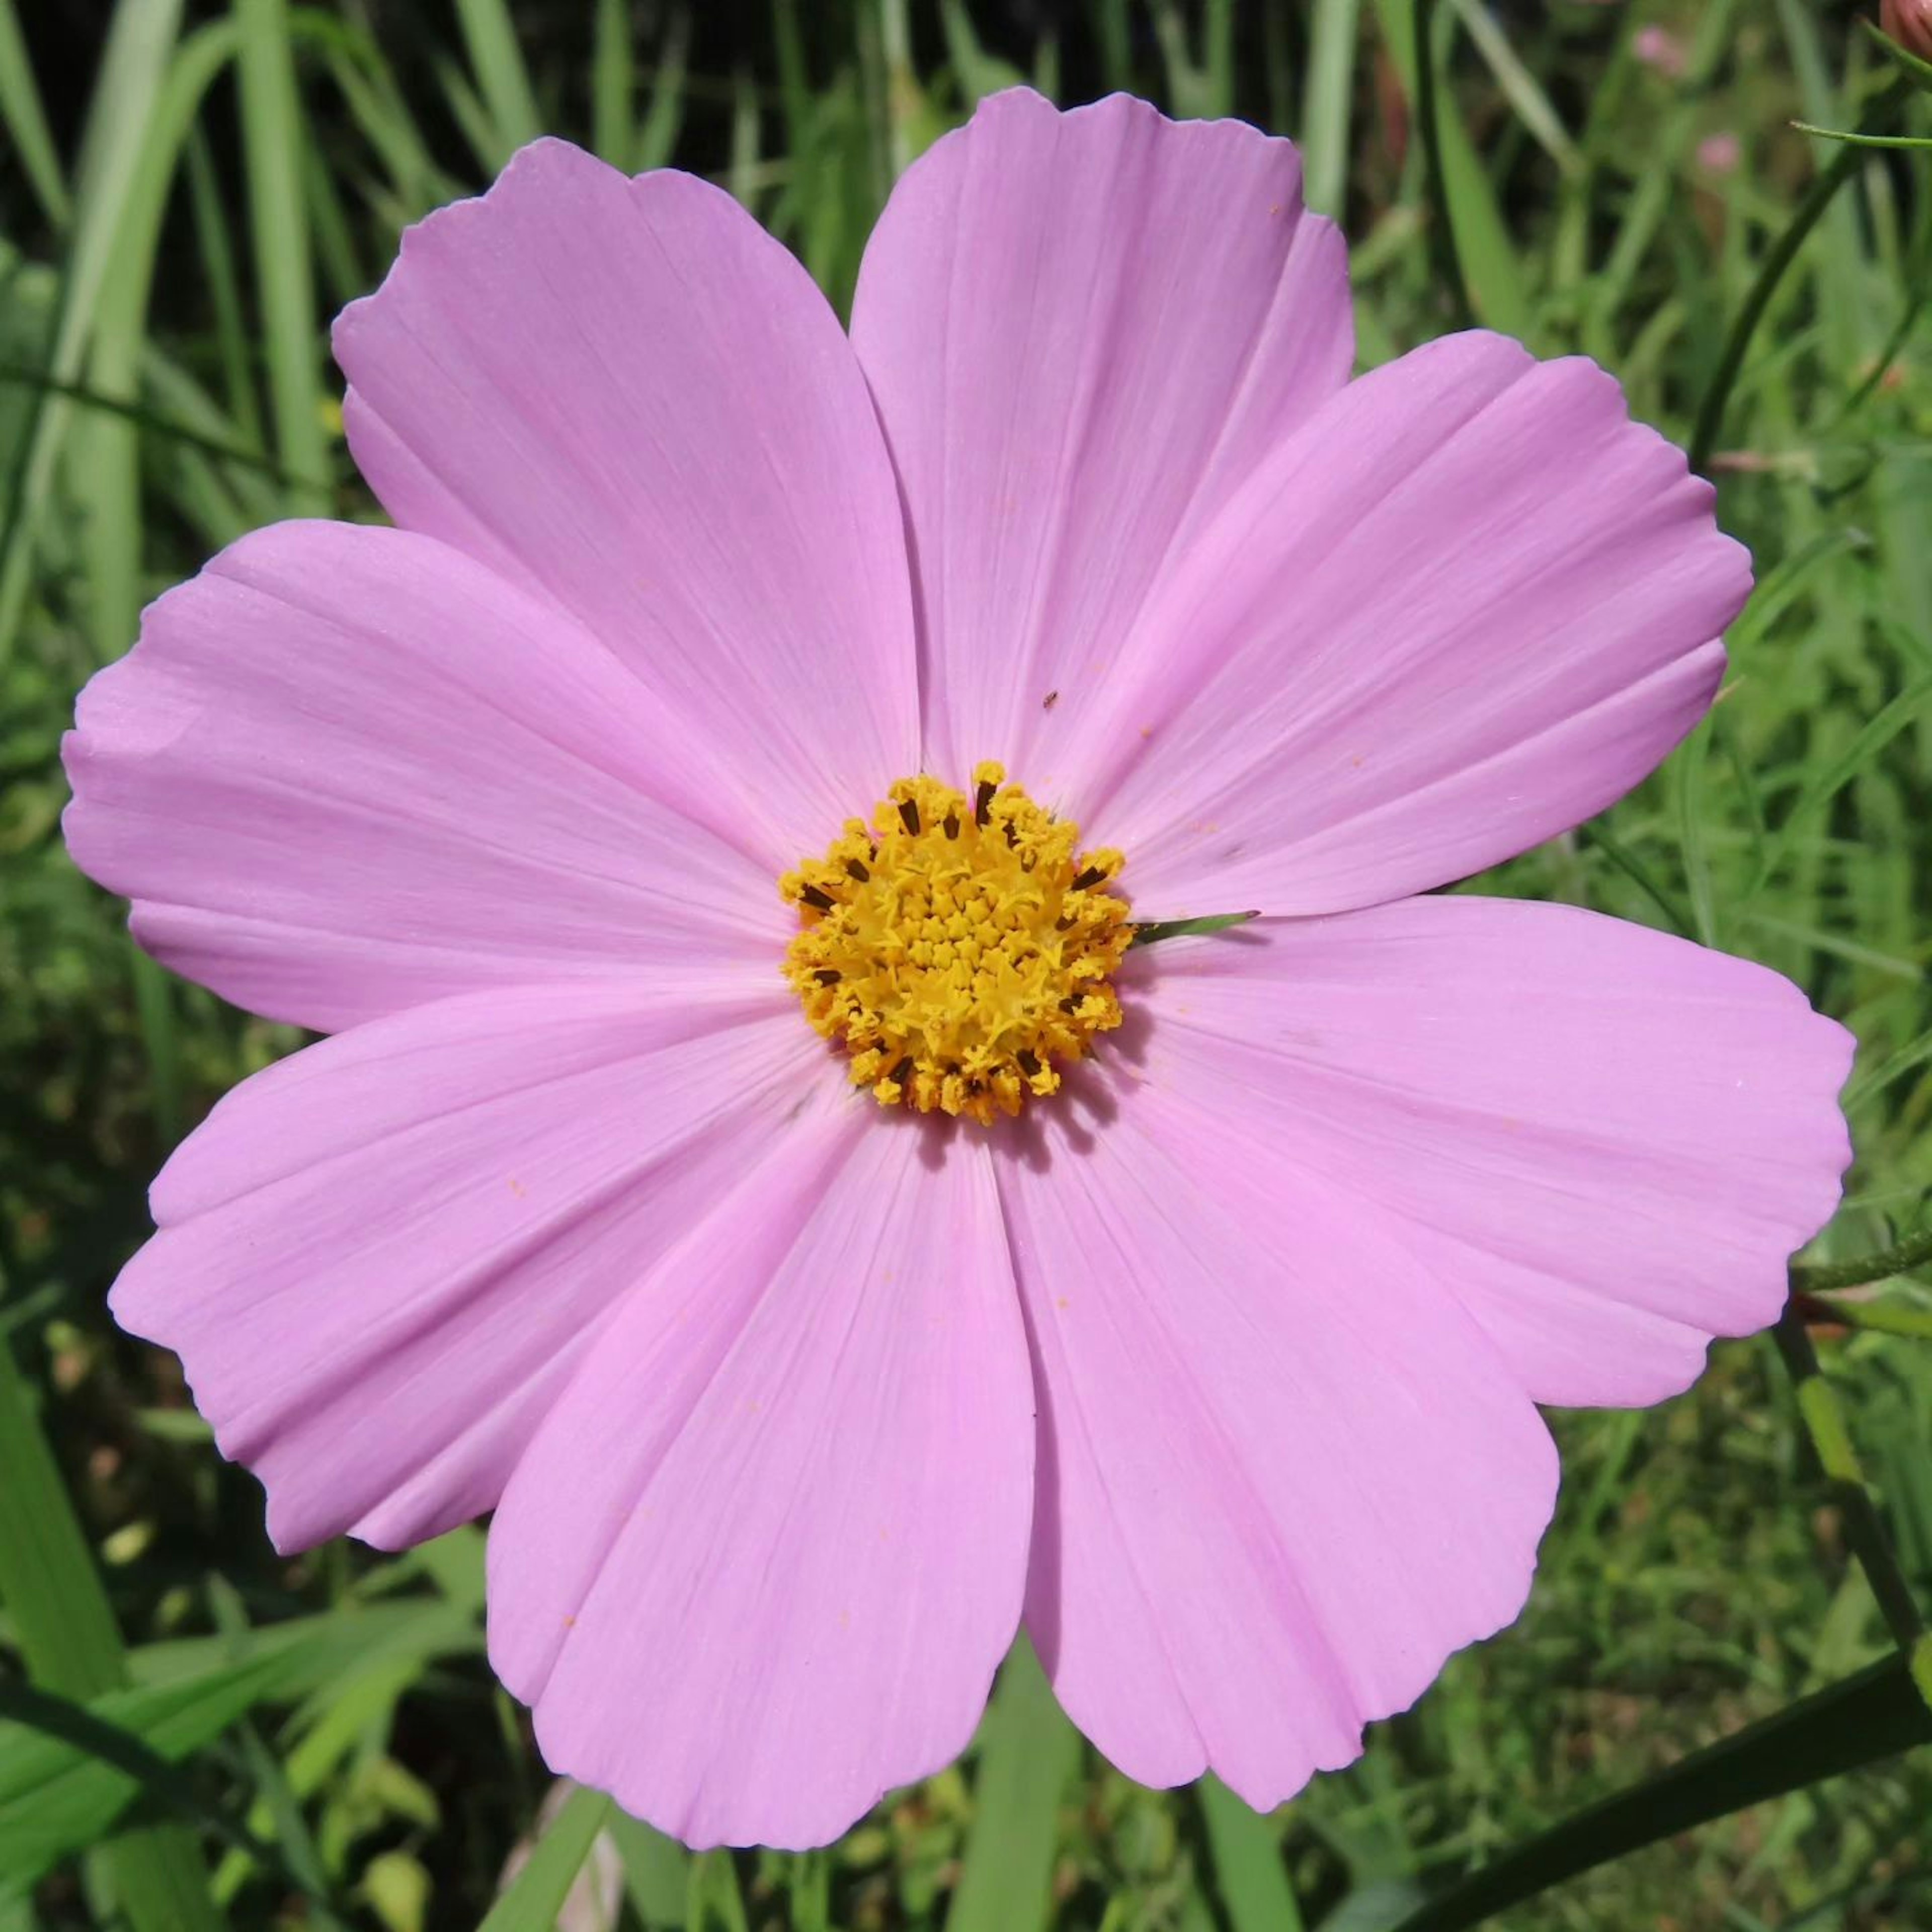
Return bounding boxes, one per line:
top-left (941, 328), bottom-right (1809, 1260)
top-left (0, 0), bottom-right (1932, 1932)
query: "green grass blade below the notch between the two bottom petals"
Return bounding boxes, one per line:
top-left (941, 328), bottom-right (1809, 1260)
top-left (947, 1636), bottom-right (1080, 1932)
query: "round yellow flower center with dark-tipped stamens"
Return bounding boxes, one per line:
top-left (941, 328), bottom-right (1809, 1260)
top-left (779, 763), bottom-right (1134, 1124)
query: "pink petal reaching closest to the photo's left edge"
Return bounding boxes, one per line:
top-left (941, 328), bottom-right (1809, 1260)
top-left (66, 524), bottom-right (786, 1028)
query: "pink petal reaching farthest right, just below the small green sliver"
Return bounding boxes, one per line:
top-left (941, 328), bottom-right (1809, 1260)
top-left (1146, 897), bottom-right (1853, 1403)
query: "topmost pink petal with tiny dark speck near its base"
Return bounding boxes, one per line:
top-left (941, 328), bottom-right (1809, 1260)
top-left (852, 89), bottom-right (1354, 792)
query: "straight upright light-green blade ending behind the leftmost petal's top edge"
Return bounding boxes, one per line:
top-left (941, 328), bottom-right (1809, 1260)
top-left (234, 0), bottom-right (331, 516)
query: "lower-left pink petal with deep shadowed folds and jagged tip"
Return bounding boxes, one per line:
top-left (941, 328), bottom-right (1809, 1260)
top-left (112, 968), bottom-right (823, 1550)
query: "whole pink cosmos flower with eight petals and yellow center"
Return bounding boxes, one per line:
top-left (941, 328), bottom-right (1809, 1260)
top-left (67, 93), bottom-right (1849, 1845)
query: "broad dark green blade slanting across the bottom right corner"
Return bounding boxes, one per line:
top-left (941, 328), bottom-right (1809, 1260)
top-left (1399, 1658), bottom-right (1932, 1932)
